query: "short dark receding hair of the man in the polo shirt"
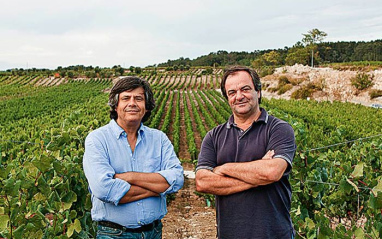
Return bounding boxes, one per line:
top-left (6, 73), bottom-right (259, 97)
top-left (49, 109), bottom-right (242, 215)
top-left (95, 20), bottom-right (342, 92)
top-left (220, 66), bottom-right (261, 104)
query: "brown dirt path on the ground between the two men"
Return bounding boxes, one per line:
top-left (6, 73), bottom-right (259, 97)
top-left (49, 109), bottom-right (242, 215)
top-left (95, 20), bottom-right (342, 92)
top-left (162, 165), bottom-right (216, 239)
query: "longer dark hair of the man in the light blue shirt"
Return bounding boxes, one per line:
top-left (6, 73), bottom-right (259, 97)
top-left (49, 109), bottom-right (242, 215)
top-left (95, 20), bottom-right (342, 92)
top-left (108, 76), bottom-right (155, 122)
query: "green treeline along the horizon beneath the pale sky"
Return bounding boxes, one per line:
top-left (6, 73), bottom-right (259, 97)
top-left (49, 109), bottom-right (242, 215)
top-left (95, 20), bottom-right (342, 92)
top-left (0, 38), bottom-right (382, 78)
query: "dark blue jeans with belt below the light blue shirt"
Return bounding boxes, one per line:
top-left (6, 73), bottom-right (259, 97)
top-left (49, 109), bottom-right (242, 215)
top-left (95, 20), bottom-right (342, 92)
top-left (97, 222), bottom-right (163, 239)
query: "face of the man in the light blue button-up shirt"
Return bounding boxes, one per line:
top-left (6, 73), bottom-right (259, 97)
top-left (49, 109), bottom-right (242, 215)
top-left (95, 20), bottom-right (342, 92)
top-left (116, 87), bottom-right (147, 125)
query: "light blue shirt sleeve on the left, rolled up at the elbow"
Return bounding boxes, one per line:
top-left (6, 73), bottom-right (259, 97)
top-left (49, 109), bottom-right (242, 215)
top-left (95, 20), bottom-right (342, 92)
top-left (83, 133), bottom-right (131, 205)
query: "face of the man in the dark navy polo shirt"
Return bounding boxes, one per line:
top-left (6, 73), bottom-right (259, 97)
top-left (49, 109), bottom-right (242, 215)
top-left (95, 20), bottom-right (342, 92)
top-left (225, 71), bottom-right (260, 116)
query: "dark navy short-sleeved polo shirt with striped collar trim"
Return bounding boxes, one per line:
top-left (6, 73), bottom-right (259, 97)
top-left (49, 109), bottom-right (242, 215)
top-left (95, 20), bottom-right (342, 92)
top-left (197, 108), bottom-right (296, 239)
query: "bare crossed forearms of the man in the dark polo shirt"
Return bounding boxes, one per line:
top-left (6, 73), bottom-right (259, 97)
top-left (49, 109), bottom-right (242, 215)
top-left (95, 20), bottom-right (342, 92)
top-left (196, 150), bottom-right (288, 195)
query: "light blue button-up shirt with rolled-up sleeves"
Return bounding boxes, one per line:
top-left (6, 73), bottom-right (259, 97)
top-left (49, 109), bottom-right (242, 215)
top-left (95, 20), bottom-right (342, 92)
top-left (83, 120), bottom-right (184, 228)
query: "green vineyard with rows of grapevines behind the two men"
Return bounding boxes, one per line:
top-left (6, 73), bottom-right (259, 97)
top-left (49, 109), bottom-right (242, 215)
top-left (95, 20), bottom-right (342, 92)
top-left (0, 69), bottom-right (382, 238)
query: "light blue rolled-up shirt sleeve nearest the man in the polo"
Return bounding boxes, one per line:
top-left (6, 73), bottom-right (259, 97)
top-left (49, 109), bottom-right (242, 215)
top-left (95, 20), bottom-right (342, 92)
top-left (158, 134), bottom-right (184, 195)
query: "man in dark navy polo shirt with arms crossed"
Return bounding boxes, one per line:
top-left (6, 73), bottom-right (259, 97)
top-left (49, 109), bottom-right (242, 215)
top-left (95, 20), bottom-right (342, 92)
top-left (196, 66), bottom-right (296, 239)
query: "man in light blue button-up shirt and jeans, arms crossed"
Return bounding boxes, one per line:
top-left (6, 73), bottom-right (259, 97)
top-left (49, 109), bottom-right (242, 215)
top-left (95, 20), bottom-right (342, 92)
top-left (83, 77), bottom-right (184, 239)
